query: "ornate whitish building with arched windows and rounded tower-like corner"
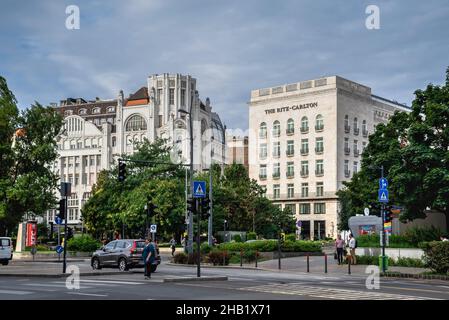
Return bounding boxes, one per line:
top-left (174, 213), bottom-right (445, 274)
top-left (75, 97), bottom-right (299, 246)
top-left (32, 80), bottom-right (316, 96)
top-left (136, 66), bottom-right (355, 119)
top-left (47, 73), bottom-right (226, 228)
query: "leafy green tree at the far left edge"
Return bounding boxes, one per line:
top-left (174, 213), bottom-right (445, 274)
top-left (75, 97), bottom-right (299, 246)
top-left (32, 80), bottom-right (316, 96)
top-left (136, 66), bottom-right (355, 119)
top-left (0, 77), bottom-right (63, 234)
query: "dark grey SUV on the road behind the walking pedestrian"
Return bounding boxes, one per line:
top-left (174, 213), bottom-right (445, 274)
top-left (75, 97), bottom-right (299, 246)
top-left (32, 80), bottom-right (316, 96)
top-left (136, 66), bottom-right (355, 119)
top-left (91, 239), bottom-right (161, 272)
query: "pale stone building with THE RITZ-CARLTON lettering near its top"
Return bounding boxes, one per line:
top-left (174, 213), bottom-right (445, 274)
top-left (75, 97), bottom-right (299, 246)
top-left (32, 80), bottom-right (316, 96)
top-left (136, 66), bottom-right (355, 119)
top-left (249, 76), bottom-right (410, 239)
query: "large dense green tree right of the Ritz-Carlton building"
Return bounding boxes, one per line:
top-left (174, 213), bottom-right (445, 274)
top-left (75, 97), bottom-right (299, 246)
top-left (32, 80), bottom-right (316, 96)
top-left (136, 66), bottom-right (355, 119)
top-left (337, 68), bottom-right (449, 230)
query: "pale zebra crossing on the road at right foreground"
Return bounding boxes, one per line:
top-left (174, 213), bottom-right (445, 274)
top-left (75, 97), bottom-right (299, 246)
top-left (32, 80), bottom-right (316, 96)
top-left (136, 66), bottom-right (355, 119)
top-left (238, 283), bottom-right (440, 300)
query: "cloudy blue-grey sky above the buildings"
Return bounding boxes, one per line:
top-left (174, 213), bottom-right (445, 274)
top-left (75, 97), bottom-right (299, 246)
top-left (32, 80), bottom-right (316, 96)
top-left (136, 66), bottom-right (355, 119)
top-left (0, 0), bottom-right (449, 130)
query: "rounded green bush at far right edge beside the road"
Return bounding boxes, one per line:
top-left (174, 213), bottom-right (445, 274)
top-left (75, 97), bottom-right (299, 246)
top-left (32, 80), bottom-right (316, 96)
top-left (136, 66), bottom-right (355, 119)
top-left (423, 241), bottom-right (449, 274)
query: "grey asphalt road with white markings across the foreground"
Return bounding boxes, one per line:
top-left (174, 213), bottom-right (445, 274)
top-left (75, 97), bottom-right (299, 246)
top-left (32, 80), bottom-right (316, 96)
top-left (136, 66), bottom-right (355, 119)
top-left (0, 262), bottom-right (449, 300)
